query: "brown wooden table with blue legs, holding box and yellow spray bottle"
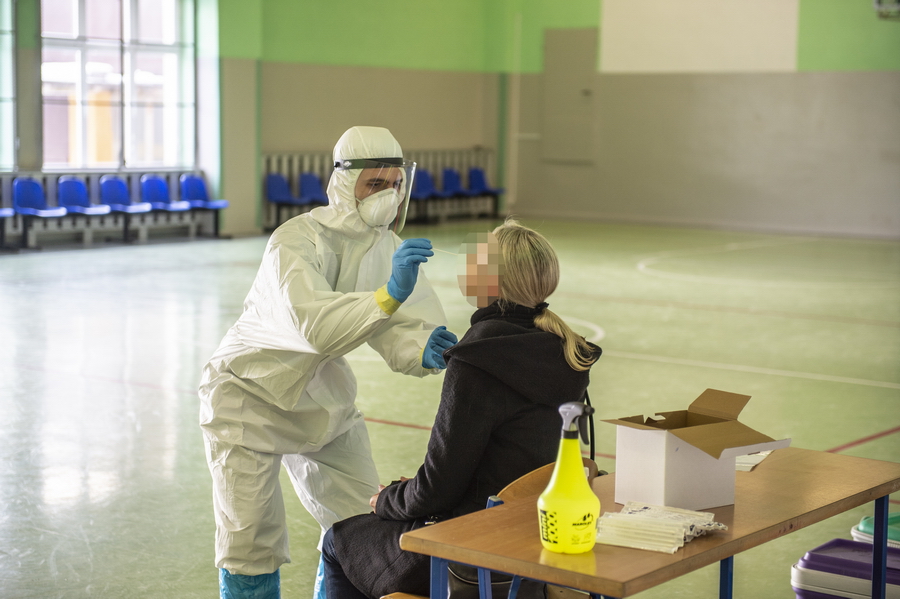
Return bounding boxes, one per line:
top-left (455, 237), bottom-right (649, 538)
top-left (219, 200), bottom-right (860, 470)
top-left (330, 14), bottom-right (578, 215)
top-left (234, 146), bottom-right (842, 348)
top-left (400, 447), bottom-right (900, 599)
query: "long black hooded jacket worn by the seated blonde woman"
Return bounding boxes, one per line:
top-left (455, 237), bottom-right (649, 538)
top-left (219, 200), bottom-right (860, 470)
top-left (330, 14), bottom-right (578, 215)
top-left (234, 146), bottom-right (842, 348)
top-left (333, 302), bottom-right (600, 597)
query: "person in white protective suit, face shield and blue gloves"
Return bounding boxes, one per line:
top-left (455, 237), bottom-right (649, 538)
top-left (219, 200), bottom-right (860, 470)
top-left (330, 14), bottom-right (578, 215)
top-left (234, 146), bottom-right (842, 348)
top-left (200, 127), bottom-right (456, 599)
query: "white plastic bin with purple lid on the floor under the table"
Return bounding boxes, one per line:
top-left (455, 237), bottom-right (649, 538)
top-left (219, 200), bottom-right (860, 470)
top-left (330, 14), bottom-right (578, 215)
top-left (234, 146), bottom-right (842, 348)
top-left (791, 539), bottom-right (900, 599)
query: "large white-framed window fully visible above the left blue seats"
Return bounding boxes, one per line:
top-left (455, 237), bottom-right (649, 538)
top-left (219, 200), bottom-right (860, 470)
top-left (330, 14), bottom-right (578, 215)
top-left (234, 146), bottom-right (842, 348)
top-left (41, 0), bottom-right (196, 169)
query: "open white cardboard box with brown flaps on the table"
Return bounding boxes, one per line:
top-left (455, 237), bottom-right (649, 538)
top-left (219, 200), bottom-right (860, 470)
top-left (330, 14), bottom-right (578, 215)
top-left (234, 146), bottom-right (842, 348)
top-left (604, 389), bottom-right (791, 510)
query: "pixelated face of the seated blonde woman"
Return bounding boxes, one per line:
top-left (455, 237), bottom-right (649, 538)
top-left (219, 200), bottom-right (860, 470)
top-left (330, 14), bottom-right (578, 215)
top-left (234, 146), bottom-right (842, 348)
top-left (457, 233), bottom-right (504, 308)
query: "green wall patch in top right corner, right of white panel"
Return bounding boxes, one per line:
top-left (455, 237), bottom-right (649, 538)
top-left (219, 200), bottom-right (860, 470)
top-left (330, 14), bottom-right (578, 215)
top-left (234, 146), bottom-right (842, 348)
top-left (797, 0), bottom-right (900, 71)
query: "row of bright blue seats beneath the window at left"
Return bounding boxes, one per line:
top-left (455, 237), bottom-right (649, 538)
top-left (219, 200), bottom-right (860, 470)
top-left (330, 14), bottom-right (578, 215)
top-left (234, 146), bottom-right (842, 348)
top-left (0, 173), bottom-right (228, 248)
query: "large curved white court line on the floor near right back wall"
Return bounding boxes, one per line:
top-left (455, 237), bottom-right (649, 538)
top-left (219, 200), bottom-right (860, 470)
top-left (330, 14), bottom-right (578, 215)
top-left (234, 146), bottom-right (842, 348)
top-left (635, 238), bottom-right (900, 289)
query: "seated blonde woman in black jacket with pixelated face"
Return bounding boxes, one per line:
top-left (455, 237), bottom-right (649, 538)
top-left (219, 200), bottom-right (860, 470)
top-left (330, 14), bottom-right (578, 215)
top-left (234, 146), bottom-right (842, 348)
top-left (322, 219), bottom-right (600, 599)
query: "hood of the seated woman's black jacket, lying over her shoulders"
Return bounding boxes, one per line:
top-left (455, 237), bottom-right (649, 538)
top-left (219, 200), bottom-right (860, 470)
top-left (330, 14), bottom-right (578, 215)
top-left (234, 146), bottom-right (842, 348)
top-left (444, 302), bottom-right (601, 406)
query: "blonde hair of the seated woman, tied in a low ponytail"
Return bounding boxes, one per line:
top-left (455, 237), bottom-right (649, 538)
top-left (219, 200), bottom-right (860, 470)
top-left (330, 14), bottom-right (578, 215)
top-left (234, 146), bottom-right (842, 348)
top-left (493, 218), bottom-right (597, 371)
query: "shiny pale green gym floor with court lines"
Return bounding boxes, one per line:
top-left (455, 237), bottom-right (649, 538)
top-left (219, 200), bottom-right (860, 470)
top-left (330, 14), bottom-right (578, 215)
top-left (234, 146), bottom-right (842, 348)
top-left (0, 219), bottom-right (900, 599)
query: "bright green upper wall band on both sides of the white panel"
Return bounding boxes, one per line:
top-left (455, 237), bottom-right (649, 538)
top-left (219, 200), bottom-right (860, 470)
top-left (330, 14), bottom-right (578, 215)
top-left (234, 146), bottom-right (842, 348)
top-left (220, 0), bottom-right (900, 73)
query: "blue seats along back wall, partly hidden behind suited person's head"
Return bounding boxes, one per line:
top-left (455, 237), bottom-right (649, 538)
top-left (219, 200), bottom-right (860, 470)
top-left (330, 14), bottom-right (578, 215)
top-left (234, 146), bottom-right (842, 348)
top-left (265, 167), bottom-right (503, 227)
